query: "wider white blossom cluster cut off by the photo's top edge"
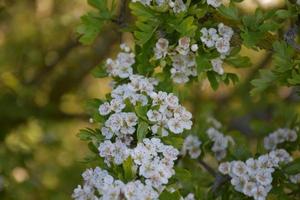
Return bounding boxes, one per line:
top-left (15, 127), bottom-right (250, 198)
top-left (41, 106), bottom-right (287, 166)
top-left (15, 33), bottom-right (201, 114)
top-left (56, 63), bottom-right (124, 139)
top-left (132, 0), bottom-right (187, 13)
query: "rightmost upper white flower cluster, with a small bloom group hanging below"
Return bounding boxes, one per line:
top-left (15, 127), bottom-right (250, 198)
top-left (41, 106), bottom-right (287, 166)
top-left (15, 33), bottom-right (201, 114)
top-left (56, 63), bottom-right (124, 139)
top-left (200, 23), bottom-right (234, 75)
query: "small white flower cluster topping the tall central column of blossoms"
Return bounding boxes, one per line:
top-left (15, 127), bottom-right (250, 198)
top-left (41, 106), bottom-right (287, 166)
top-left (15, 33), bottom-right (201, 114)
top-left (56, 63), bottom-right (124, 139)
top-left (105, 44), bottom-right (135, 78)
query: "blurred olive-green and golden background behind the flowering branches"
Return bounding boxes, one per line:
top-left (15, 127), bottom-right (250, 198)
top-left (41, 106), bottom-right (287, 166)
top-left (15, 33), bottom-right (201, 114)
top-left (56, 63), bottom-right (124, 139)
top-left (0, 0), bottom-right (299, 200)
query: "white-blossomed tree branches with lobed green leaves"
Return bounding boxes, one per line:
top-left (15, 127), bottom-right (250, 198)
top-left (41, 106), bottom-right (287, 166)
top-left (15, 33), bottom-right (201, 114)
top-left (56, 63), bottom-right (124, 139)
top-left (72, 0), bottom-right (300, 200)
